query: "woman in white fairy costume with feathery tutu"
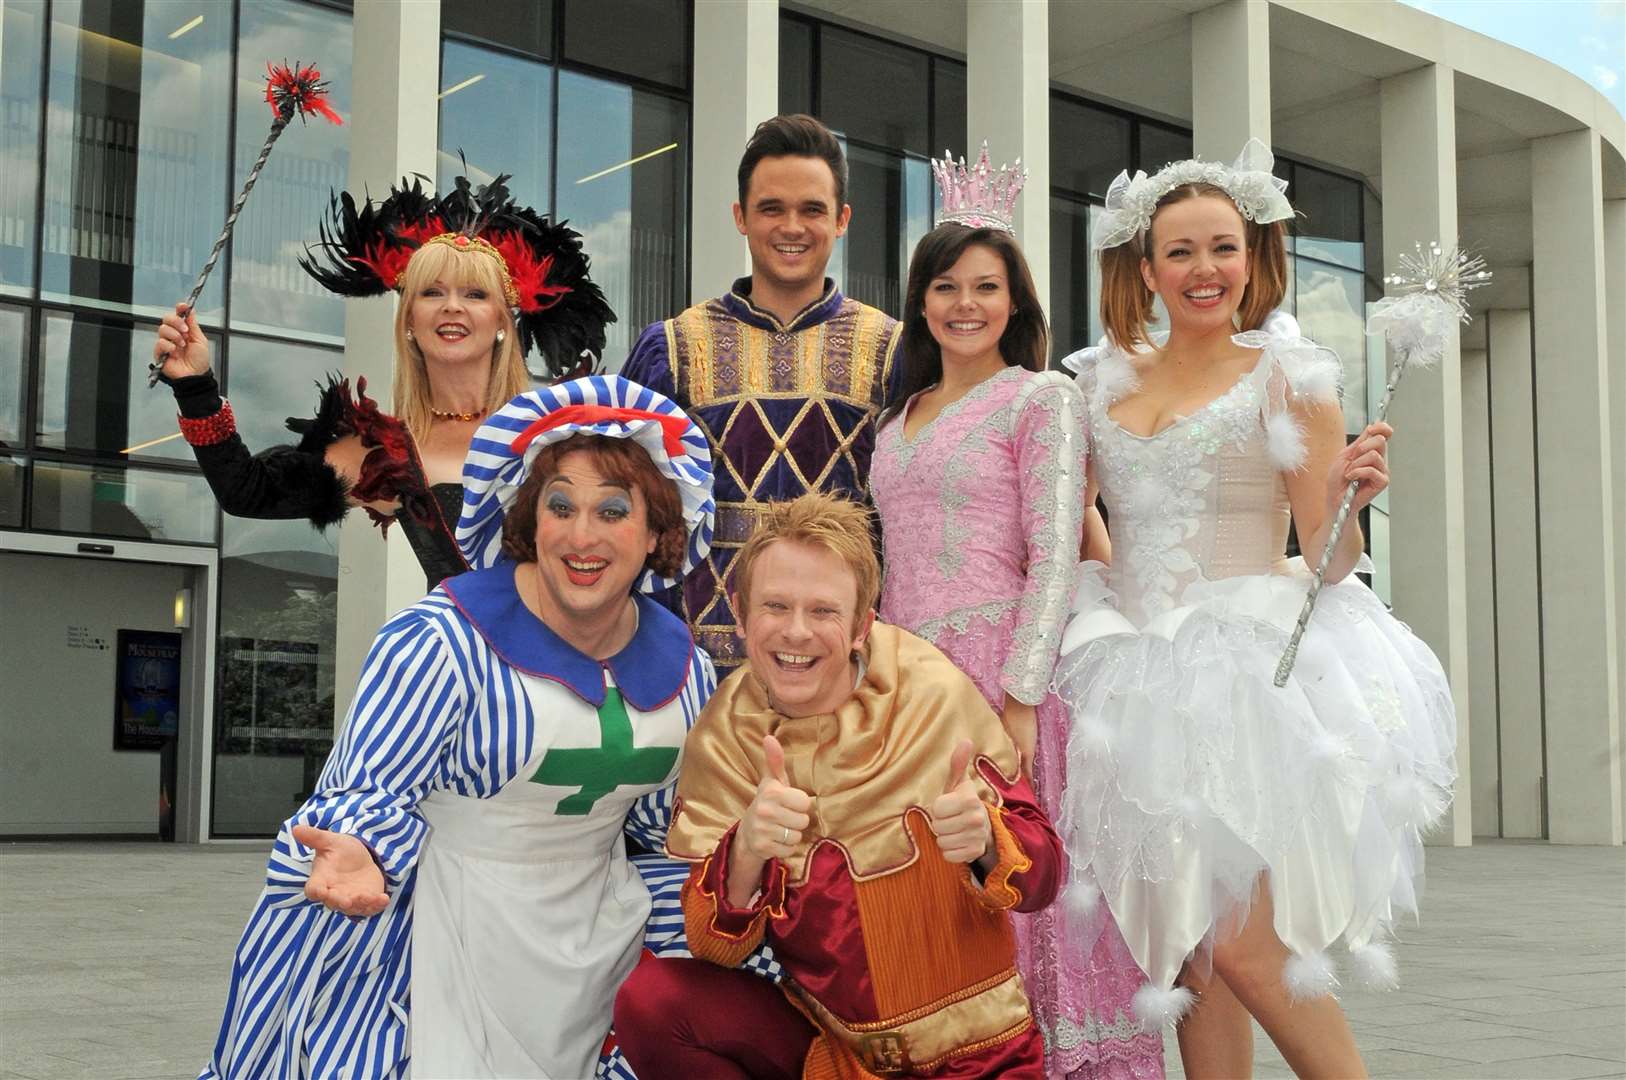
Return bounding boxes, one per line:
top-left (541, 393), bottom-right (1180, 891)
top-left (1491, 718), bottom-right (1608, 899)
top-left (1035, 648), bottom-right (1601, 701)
top-left (1057, 142), bottom-right (1455, 1077)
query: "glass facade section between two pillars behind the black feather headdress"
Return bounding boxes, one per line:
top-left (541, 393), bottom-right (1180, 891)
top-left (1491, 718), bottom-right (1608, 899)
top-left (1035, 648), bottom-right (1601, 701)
top-left (437, 0), bottom-right (691, 371)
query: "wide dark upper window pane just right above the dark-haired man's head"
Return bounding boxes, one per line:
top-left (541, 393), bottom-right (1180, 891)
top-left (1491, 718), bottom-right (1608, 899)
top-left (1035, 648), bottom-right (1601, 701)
top-left (818, 26), bottom-right (943, 155)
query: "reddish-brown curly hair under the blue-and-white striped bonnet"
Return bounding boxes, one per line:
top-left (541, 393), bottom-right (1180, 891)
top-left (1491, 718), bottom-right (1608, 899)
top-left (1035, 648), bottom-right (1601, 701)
top-left (502, 434), bottom-right (689, 577)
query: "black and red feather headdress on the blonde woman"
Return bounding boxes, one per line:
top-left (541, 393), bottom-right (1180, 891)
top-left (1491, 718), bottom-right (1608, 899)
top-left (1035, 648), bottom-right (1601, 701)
top-left (299, 174), bottom-right (615, 377)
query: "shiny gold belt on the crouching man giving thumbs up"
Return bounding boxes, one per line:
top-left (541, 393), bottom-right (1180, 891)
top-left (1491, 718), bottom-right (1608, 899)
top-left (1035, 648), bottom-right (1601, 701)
top-left (797, 969), bottom-right (1033, 1075)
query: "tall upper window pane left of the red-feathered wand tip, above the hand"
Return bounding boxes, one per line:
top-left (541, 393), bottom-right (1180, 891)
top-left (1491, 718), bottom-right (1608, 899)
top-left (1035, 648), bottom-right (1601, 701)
top-left (41, 0), bottom-right (232, 320)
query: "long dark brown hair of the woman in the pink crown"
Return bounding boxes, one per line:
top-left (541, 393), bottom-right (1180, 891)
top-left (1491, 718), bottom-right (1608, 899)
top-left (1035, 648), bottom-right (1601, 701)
top-left (883, 221), bottom-right (1050, 420)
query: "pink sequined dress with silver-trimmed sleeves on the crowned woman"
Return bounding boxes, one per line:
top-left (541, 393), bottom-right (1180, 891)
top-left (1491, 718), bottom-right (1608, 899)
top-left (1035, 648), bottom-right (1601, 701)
top-left (870, 368), bottom-right (1163, 1078)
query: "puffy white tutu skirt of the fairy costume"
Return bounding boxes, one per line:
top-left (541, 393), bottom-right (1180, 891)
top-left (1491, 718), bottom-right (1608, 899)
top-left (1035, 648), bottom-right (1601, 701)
top-left (1055, 560), bottom-right (1457, 1021)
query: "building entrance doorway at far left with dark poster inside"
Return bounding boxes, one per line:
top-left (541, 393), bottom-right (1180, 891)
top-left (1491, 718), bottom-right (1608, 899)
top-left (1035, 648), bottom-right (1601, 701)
top-left (0, 533), bottom-right (216, 841)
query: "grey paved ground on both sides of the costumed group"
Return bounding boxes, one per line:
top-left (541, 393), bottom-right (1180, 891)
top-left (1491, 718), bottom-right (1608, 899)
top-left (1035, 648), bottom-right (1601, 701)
top-left (0, 844), bottom-right (1626, 1080)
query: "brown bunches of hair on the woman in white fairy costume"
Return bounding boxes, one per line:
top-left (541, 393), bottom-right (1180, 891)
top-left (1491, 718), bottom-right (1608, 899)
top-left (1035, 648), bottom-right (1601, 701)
top-left (1101, 184), bottom-right (1288, 350)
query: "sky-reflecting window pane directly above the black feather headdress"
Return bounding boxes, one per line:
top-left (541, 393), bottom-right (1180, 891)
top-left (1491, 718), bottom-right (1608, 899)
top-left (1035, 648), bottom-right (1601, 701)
top-left (437, 41), bottom-right (553, 213)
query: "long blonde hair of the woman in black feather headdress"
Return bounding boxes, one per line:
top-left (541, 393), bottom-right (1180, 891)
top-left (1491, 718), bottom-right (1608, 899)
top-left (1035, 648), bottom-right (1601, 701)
top-left (393, 244), bottom-right (532, 442)
